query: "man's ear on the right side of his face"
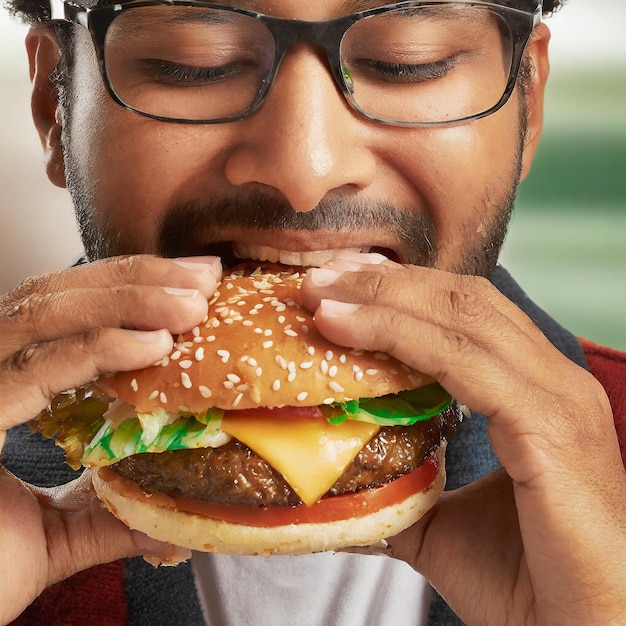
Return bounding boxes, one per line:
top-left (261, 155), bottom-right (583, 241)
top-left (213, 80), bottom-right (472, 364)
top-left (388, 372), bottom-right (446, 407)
top-left (522, 24), bottom-right (550, 180)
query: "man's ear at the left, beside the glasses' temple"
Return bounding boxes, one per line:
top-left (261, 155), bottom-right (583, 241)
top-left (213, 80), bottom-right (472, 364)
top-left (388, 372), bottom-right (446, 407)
top-left (26, 25), bottom-right (65, 187)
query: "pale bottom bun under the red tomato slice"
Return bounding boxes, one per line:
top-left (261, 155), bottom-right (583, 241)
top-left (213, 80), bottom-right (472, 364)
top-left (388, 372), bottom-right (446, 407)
top-left (92, 444), bottom-right (446, 556)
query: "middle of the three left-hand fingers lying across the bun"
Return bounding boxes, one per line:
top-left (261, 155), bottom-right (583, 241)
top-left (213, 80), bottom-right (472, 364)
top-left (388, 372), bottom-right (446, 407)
top-left (0, 285), bottom-right (208, 356)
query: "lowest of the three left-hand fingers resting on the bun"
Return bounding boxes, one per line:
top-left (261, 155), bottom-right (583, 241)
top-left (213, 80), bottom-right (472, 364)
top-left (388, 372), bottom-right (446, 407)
top-left (0, 328), bottom-right (173, 430)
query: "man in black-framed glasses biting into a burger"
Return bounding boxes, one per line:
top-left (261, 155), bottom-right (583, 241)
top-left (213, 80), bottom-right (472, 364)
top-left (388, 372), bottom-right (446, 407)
top-left (0, 0), bottom-right (626, 624)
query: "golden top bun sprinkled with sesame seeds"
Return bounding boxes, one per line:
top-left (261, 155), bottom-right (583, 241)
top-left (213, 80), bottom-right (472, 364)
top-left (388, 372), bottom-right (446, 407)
top-left (98, 265), bottom-right (433, 413)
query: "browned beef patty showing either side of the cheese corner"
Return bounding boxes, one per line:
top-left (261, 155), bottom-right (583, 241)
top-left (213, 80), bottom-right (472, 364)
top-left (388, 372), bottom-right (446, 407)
top-left (111, 404), bottom-right (460, 507)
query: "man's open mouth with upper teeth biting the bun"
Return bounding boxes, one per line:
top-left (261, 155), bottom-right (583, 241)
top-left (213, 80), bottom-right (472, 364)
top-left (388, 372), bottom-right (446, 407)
top-left (202, 241), bottom-right (401, 268)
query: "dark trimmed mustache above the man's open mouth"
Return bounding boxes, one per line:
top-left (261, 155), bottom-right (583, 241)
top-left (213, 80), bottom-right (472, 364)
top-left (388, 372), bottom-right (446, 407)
top-left (157, 191), bottom-right (436, 266)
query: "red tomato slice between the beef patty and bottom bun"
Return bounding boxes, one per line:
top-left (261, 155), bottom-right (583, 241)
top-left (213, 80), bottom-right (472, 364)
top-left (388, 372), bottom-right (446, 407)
top-left (174, 453), bottom-right (438, 527)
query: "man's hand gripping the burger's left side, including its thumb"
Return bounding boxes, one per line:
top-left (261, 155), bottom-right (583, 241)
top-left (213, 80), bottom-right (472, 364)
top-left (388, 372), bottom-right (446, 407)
top-left (0, 256), bottom-right (221, 624)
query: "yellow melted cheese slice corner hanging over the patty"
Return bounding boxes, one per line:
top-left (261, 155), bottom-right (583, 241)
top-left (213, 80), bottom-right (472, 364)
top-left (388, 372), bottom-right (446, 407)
top-left (222, 413), bottom-right (380, 506)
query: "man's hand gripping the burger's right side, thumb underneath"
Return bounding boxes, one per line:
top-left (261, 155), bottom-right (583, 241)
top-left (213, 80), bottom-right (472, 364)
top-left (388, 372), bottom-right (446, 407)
top-left (302, 253), bottom-right (626, 626)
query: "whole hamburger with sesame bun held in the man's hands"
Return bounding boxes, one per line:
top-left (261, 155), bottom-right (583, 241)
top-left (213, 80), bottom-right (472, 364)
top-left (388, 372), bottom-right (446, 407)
top-left (33, 265), bottom-right (459, 555)
